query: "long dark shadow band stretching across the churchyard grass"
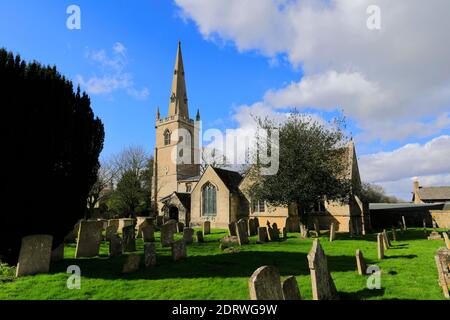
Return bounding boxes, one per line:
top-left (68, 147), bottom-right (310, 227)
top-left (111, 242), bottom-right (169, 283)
top-left (50, 251), bottom-right (355, 280)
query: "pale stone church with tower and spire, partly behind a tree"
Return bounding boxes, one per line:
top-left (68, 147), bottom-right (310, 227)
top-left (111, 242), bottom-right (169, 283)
top-left (152, 43), bottom-right (370, 234)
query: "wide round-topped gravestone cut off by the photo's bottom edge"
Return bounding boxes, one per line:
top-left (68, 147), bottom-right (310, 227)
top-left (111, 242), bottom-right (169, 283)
top-left (248, 266), bottom-right (283, 300)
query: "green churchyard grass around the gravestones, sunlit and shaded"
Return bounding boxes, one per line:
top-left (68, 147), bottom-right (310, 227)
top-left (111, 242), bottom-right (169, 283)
top-left (0, 229), bottom-right (444, 300)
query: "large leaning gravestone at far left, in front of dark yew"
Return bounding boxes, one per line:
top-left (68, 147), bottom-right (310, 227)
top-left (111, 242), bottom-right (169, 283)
top-left (16, 235), bottom-right (53, 277)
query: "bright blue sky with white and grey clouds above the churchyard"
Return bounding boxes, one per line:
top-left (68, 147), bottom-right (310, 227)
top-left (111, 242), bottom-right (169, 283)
top-left (0, 0), bottom-right (450, 199)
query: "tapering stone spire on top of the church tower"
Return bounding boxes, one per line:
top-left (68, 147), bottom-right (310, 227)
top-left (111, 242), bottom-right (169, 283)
top-left (169, 42), bottom-right (189, 118)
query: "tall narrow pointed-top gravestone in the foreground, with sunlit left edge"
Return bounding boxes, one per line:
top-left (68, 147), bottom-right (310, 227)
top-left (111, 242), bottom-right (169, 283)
top-left (308, 239), bottom-right (339, 300)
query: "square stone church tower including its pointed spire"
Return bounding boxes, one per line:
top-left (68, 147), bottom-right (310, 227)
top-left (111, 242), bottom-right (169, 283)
top-left (152, 43), bottom-right (200, 212)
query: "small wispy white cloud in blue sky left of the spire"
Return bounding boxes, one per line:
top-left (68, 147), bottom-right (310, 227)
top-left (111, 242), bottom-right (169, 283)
top-left (76, 42), bottom-right (149, 100)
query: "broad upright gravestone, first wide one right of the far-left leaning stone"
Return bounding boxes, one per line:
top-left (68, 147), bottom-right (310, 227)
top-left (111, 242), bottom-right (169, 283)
top-left (75, 221), bottom-right (103, 258)
